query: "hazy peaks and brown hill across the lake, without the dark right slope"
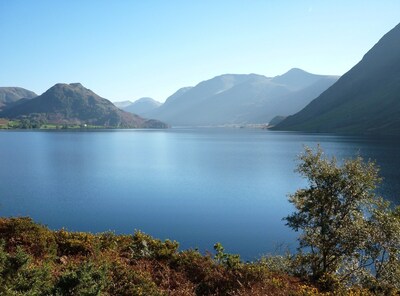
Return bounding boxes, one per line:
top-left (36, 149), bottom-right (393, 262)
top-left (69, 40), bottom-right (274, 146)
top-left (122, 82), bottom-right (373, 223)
top-left (0, 68), bottom-right (338, 127)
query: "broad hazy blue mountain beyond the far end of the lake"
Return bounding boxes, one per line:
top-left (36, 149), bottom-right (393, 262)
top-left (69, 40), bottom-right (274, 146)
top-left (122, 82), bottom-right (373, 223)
top-left (146, 69), bottom-right (337, 126)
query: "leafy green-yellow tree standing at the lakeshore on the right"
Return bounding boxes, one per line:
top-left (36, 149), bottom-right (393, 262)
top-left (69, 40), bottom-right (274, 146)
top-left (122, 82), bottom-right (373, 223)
top-left (285, 146), bottom-right (400, 288)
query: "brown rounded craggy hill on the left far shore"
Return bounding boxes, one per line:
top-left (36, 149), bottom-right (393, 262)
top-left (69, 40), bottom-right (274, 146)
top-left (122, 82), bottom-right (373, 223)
top-left (0, 83), bottom-right (166, 128)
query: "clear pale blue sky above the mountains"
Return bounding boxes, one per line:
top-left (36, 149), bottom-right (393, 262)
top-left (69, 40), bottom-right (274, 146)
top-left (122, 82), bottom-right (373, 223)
top-left (0, 0), bottom-right (400, 102)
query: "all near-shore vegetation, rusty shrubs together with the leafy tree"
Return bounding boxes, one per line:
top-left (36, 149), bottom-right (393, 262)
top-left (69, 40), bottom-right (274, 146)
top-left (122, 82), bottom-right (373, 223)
top-left (0, 148), bottom-right (400, 296)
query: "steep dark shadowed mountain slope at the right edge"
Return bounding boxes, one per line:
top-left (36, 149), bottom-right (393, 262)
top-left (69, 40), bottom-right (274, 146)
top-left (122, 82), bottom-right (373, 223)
top-left (273, 24), bottom-right (400, 135)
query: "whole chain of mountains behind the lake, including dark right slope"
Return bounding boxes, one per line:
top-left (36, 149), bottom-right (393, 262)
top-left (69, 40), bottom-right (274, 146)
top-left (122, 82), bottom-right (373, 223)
top-left (0, 24), bottom-right (400, 135)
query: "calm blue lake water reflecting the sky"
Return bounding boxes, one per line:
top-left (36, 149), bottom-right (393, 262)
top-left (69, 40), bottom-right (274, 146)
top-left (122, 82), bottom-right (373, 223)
top-left (0, 128), bottom-right (400, 260)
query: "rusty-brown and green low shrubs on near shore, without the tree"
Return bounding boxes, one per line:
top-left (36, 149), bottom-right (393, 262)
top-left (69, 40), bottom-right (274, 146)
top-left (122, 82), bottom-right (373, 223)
top-left (0, 218), bottom-right (328, 295)
